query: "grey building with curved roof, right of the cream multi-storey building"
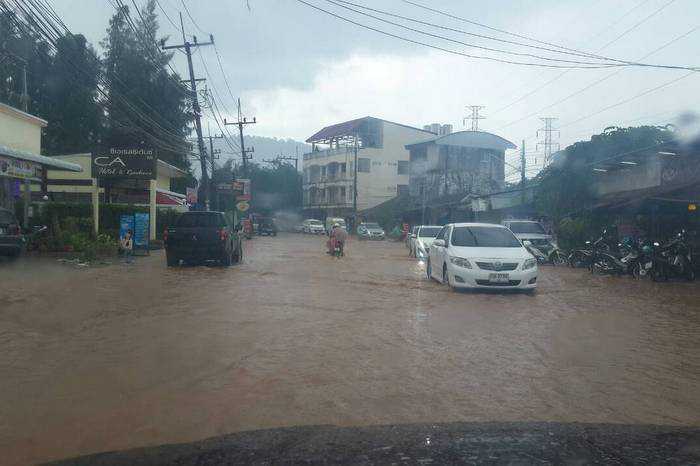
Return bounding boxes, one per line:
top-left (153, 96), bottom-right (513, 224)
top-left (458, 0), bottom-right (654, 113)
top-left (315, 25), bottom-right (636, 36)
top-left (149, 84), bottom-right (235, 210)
top-left (406, 131), bottom-right (515, 204)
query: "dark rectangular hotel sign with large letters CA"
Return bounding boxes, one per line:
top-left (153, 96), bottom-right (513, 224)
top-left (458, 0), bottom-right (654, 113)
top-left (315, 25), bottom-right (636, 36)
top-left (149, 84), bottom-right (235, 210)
top-left (91, 147), bottom-right (158, 180)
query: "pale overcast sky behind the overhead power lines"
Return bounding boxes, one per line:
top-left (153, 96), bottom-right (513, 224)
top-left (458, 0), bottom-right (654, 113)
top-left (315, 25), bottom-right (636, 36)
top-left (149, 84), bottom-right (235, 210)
top-left (51, 0), bottom-right (700, 178)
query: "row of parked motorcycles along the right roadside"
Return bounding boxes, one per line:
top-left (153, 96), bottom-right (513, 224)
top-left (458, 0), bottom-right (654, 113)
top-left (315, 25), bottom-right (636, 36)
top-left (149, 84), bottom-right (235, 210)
top-left (567, 230), bottom-right (695, 281)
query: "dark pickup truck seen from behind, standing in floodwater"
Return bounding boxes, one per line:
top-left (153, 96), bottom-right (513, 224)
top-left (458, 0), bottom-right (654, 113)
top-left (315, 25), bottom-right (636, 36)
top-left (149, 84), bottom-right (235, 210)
top-left (163, 212), bottom-right (243, 267)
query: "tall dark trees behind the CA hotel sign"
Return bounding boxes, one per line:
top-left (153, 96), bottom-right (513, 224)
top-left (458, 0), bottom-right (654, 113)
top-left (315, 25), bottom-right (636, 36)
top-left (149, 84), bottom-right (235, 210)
top-left (0, 0), bottom-right (192, 169)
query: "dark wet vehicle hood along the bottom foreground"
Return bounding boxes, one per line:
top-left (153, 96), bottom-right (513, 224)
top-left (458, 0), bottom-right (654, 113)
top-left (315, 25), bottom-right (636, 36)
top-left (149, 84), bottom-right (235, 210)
top-left (50, 422), bottom-right (700, 466)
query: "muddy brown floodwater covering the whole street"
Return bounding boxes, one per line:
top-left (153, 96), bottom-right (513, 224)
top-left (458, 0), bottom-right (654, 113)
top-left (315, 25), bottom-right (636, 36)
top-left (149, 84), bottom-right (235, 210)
top-left (0, 235), bottom-right (700, 464)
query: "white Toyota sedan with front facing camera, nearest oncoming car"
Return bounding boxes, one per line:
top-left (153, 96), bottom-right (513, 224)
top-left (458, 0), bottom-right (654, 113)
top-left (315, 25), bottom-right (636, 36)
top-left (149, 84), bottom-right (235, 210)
top-left (427, 223), bottom-right (537, 292)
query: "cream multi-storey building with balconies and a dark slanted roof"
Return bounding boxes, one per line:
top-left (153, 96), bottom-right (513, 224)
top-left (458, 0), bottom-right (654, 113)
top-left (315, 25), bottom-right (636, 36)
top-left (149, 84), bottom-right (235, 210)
top-left (303, 117), bottom-right (435, 218)
